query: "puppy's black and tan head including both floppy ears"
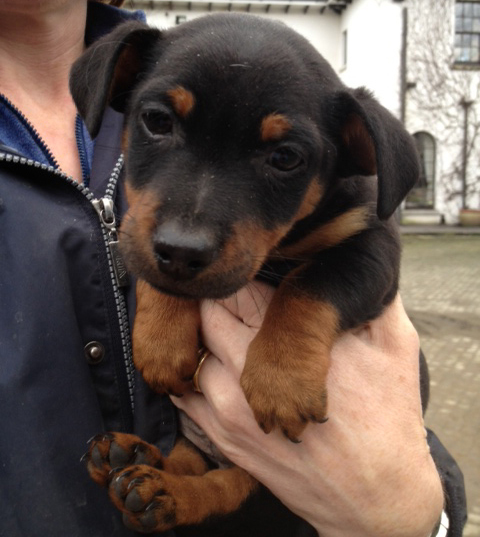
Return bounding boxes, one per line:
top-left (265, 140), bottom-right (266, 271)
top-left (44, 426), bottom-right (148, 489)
top-left (71, 14), bottom-right (416, 298)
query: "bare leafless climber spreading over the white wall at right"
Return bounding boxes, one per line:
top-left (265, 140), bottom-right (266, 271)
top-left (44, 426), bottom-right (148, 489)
top-left (407, 0), bottom-right (480, 216)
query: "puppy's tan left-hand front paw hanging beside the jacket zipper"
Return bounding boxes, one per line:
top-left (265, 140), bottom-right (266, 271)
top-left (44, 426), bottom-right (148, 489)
top-left (133, 280), bottom-right (200, 395)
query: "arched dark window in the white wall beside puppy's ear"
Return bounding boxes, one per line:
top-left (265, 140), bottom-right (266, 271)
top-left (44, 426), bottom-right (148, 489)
top-left (406, 132), bottom-right (435, 209)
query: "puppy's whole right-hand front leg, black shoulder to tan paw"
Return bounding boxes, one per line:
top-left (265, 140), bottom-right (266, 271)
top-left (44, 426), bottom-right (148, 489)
top-left (241, 226), bottom-right (400, 441)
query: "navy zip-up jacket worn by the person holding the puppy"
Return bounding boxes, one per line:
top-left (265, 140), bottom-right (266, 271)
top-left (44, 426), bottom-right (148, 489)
top-left (0, 3), bottom-right (465, 537)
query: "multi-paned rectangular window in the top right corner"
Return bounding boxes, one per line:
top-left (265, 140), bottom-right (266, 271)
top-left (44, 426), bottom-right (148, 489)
top-left (455, 0), bottom-right (480, 64)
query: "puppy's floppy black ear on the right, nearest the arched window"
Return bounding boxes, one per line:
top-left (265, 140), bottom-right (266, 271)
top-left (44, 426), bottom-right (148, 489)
top-left (328, 88), bottom-right (420, 219)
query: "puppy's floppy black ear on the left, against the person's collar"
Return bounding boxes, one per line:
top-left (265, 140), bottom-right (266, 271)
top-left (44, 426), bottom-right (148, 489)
top-left (70, 22), bottom-right (162, 137)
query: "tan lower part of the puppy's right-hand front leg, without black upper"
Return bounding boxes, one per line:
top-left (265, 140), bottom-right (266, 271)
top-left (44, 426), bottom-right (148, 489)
top-left (241, 280), bottom-right (338, 441)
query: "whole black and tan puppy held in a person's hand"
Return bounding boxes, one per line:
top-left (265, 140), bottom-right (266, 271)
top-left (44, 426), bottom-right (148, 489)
top-left (71, 14), bottom-right (418, 531)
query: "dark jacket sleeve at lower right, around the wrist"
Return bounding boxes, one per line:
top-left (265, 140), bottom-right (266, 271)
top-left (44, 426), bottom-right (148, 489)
top-left (427, 430), bottom-right (467, 537)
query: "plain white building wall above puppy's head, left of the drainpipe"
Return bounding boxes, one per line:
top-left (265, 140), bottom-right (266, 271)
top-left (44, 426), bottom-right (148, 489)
top-left (140, 0), bottom-right (403, 116)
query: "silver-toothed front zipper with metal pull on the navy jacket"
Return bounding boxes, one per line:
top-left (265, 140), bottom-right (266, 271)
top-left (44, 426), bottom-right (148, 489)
top-left (0, 152), bottom-right (135, 413)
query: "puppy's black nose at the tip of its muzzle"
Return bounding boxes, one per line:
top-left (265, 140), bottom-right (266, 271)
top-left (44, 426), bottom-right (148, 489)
top-left (153, 221), bottom-right (216, 280)
